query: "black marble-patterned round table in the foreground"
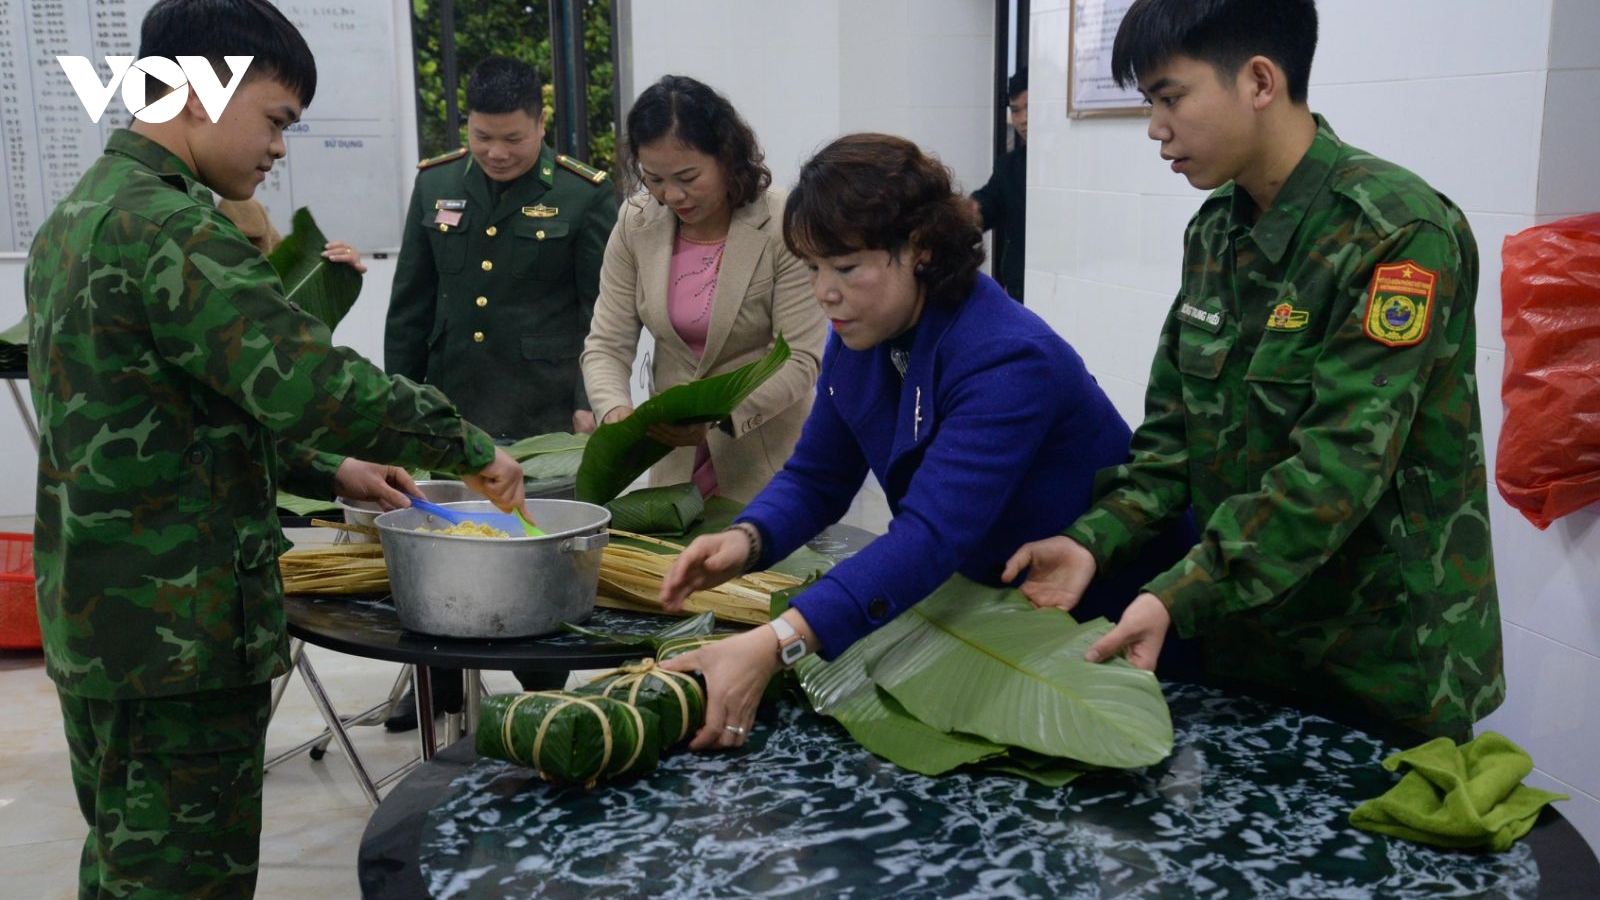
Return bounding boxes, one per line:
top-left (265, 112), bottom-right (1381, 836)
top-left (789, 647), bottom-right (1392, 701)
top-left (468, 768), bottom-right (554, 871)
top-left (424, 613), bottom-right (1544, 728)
top-left (358, 684), bottom-right (1600, 900)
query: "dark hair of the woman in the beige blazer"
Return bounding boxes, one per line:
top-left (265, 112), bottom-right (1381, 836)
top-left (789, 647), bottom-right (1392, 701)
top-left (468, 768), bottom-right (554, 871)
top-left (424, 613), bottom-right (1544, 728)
top-left (624, 75), bottom-right (773, 210)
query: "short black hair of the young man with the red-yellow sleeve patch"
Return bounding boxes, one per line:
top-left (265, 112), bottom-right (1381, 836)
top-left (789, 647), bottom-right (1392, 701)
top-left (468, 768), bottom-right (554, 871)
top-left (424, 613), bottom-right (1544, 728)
top-left (1110, 0), bottom-right (1317, 102)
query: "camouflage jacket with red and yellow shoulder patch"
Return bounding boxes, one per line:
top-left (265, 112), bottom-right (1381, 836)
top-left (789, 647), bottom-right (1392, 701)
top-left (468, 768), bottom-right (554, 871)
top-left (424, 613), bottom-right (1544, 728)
top-left (1067, 119), bottom-right (1506, 733)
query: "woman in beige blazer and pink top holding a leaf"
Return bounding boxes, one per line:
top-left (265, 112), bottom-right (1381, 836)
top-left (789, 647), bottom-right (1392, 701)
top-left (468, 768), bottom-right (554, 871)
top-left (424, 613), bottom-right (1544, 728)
top-left (581, 75), bottom-right (827, 503)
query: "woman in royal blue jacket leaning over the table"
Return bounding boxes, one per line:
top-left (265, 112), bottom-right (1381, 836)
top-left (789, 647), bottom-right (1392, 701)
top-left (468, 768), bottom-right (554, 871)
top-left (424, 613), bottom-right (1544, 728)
top-left (661, 135), bottom-right (1190, 749)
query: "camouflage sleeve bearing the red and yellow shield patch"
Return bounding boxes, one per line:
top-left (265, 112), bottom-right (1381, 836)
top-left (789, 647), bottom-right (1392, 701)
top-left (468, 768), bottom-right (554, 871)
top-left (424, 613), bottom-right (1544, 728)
top-left (1146, 221), bottom-right (1474, 636)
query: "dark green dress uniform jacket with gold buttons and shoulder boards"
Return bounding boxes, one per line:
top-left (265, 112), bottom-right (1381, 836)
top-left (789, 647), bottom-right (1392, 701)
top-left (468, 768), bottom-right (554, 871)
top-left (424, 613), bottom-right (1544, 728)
top-left (384, 147), bottom-right (616, 439)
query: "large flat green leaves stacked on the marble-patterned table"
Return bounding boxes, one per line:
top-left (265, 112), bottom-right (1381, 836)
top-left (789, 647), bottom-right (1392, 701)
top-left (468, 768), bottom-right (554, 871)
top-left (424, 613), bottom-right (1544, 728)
top-left (556, 575), bottom-right (1173, 786)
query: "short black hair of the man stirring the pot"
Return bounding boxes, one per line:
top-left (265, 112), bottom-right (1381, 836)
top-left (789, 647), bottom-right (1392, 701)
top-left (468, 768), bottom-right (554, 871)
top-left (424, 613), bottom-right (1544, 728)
top-left (139, 0), bottom-right (317, 107)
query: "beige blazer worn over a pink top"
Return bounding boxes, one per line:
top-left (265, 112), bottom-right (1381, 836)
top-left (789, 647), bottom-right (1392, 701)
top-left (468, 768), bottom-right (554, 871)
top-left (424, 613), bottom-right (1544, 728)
top-left (581, 189), bottom-right (827, 503)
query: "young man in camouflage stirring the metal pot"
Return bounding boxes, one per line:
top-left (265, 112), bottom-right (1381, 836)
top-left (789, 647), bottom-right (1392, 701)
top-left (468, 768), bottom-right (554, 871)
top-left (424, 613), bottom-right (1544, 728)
top-left (26, 0), bottom-right (523, 900)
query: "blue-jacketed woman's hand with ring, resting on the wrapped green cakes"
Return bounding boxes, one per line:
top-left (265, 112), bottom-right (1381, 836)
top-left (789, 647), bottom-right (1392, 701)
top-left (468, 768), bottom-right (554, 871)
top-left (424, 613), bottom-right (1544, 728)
top-left (661, 621), bottom-right (782, 749)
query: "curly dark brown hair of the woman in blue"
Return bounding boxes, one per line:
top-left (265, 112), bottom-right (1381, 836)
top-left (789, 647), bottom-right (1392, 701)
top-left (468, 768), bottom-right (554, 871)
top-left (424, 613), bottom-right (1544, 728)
top-left (784, 135), bottom-right (984, 307)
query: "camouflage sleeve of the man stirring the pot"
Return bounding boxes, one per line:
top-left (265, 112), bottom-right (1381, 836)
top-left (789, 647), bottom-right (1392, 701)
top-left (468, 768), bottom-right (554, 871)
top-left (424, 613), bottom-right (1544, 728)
top-left (144, 207), bottom-right (494, 471)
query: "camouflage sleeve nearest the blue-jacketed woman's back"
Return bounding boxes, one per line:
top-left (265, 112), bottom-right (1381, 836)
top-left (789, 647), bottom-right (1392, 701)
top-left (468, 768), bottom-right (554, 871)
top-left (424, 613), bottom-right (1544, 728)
top-left (1066, 304), bottom-right (1190, 572)
